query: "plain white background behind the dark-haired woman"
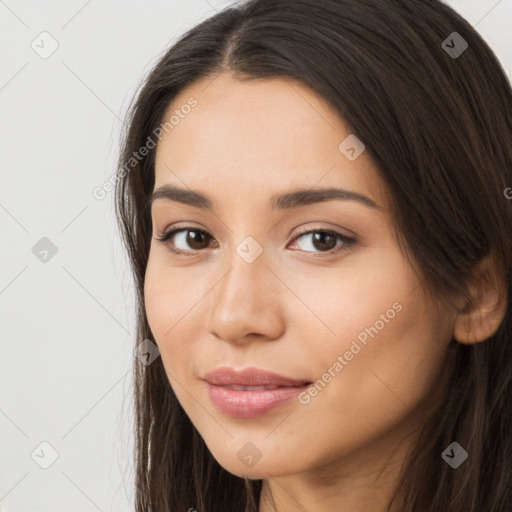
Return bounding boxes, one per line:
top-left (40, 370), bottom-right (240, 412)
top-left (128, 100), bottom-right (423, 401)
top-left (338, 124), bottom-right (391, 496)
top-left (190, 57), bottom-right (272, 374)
top-left (0, 0), bottom-right (512, 512)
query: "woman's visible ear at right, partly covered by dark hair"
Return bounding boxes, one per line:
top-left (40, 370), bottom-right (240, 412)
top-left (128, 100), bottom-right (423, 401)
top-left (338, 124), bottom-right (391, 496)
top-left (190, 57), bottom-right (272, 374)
top-left (453, 256), bottom-right (507, 344)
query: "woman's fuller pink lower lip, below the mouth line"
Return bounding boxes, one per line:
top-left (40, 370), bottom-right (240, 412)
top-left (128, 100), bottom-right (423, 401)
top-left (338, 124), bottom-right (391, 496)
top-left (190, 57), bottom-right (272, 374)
top-left (206, 382), bottom-right (309, 418)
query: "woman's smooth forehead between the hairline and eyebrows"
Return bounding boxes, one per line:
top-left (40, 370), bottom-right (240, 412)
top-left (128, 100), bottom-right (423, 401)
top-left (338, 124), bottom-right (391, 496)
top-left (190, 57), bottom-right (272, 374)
top-left (155, 73), bottom-right (386, 210)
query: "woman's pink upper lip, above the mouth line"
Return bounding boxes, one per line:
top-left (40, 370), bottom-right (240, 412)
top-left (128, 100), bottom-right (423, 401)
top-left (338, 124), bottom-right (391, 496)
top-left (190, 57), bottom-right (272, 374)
top-left (203, 366), bottom-right (311, 386)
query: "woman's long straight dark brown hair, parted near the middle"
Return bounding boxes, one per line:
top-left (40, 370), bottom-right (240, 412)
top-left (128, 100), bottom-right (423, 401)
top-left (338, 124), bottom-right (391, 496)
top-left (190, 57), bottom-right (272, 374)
top-left (115, 0), bottom-right (512, 512)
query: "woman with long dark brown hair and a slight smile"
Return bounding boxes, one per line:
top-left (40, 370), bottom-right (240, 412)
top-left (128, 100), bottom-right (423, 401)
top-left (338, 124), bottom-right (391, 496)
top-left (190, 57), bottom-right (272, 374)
top-left (116, 0), bottom-right (512, 512)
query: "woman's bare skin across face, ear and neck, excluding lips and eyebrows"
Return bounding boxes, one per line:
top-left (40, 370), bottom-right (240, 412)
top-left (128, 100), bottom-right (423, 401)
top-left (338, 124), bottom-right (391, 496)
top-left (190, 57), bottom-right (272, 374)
top-left (145, 73), bottom-right (502, 512)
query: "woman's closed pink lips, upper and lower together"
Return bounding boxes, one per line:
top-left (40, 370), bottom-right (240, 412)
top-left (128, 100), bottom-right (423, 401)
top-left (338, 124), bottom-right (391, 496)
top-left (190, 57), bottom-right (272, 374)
top-left (203, 367), bottom-right (311, 418)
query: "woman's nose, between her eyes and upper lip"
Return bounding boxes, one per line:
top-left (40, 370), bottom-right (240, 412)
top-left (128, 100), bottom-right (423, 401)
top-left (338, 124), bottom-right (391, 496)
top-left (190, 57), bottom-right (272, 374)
top-left (209, 242), bottom-right (284, 345)
